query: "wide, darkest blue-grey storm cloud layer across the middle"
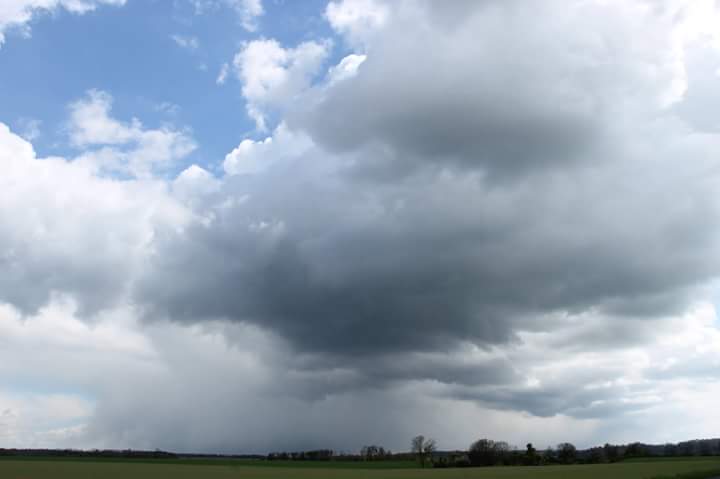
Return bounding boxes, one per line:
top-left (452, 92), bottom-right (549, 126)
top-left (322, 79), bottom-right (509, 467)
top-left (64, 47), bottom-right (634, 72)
top-left (138, 123), bottom-right (718, 377)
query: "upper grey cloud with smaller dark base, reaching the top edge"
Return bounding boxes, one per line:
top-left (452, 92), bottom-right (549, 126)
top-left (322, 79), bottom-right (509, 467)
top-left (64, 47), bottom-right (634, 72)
top-left (289, 2), bottom-right (682, 180)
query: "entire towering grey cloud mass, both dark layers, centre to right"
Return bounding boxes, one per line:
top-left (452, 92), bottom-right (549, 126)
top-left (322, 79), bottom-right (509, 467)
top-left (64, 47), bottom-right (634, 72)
top-left (136, 2), bottom-right (720, 417)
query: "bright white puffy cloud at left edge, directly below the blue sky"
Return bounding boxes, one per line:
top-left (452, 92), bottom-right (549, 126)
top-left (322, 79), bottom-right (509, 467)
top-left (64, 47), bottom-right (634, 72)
top-left (0, 124), bottom-right (186, 312)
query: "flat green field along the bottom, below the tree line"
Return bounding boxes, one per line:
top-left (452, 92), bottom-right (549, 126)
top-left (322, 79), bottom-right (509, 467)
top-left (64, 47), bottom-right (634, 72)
top-left (0, 458), bottom-right (720, 479)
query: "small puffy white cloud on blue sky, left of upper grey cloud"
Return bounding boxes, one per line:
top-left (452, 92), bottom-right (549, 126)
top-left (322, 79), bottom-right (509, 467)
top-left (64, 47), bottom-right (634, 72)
top-left (233, 40), bottom-right (331, 131)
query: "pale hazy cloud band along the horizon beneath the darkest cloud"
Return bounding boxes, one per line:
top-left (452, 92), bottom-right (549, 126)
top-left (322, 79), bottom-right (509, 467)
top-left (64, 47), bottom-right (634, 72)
top-left (0, 294), bottom-right (717, 453)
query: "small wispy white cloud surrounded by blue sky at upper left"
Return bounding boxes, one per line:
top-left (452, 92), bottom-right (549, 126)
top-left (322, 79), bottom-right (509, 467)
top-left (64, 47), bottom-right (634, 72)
top-left (68, 90), bottom-right (196, 178)
